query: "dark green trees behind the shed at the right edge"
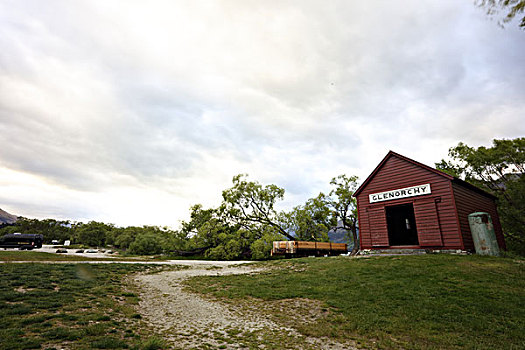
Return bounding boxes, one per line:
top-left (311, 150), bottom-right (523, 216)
top-left (436, 137), bottom-right (525, 254)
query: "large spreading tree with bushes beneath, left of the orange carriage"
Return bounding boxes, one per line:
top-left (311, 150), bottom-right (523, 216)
top-left (173, 175), bottom-right (286, 260)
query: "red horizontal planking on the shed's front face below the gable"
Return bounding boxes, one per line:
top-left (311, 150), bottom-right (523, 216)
top-left (357, 155), bottom-right (462, 249)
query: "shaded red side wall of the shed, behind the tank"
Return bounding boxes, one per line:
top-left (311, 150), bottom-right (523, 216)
top-left (452, 183), bottom-right (506, 250)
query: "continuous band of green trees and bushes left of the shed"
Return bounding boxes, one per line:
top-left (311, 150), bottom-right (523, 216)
top-left (0, 175), bottom-right (358, 260)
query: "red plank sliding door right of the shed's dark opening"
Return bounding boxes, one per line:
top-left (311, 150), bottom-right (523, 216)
top-left (414, 198), bottom-right (443, 246)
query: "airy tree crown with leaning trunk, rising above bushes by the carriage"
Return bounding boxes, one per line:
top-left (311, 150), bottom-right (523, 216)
top-left (220, 174), bottom-right (295, 240)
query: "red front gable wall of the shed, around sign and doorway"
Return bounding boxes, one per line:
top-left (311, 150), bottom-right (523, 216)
top-left (357, 155), bottom-right (463, 249)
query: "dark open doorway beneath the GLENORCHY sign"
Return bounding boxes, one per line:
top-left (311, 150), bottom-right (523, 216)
top-left (385, 203), bottom-right (419, 246)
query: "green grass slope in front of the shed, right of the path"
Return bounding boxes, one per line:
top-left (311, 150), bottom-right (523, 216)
top-left (188, 255), bottom-right (525, 349)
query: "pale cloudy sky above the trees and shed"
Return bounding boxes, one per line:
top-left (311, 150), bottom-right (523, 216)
top-left (0, 0), bottom-right (525, 229)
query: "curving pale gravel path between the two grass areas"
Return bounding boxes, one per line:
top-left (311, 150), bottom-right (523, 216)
top-left (133, 262), bottom-right (355, 349)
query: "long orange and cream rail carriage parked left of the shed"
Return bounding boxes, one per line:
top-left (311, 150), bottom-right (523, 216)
top-left (271, 241), bottom-right (348, 257)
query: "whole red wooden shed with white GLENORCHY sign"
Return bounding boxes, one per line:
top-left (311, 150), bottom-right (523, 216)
top-left (354, 151), bottom-right (505, 251)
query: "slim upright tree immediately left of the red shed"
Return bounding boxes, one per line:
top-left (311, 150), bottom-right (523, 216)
top-left (330, 175), bottom-right (359, 255)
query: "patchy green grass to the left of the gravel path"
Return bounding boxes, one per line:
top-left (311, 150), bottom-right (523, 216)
top-left (0, 264), bottom-right (163, 350)
